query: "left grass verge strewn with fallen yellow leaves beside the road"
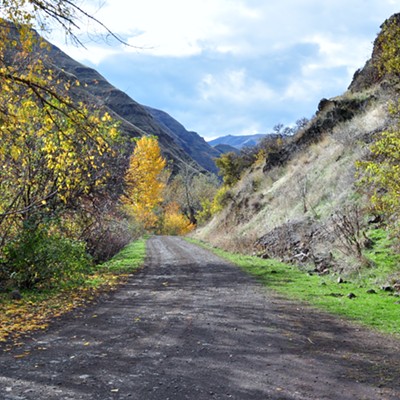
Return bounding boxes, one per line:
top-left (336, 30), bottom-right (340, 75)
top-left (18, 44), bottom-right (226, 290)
top-left (0, 238), bottom-right (146, 350)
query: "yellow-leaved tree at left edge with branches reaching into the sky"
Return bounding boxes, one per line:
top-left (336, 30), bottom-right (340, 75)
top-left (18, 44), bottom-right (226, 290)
top-left (0, 0), bottom-right (125, 219)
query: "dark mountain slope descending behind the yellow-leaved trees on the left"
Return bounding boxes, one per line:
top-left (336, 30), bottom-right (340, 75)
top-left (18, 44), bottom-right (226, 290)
top-left (31, 32), bottom-right (219, 172)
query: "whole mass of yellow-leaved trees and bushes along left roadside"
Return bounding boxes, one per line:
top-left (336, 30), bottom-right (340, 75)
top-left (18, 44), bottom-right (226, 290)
top-left (0, 0), bottom-right (137, 295)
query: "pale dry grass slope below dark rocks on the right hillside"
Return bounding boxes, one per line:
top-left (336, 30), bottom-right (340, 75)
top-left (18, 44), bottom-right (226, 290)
top-left (195, 94), bottom-right (388, 260)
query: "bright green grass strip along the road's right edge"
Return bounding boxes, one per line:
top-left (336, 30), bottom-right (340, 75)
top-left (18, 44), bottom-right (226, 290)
top-left (188, 239), bottom-right (400, 335)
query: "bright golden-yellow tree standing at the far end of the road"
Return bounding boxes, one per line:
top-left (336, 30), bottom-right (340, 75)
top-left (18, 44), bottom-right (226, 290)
top-left (123, 136), bottom-right (166, 230)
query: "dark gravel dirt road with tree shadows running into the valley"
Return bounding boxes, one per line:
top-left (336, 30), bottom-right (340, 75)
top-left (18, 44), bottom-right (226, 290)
top-left (0, 237), bottom-right (400, 400)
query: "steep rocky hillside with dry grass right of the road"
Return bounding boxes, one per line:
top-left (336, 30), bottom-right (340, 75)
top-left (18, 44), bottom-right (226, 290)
top-left (196, 16), bottom-right (400, 271)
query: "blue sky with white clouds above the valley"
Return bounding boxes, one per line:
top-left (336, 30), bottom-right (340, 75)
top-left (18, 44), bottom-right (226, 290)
top-left (49, 0), bottom-right (400, 140)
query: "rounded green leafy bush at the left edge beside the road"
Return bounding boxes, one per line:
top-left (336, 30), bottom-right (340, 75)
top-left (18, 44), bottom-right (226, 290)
top-left (1, 226), bottom-right (91, 289)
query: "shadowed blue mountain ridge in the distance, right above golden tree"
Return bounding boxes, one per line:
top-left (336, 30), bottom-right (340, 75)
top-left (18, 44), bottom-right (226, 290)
top-left (145, 106), bottom-right (221, 174)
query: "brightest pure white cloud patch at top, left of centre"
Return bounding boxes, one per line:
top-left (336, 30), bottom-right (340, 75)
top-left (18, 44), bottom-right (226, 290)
top-left (81, 0), bottom-right (257, 57)
